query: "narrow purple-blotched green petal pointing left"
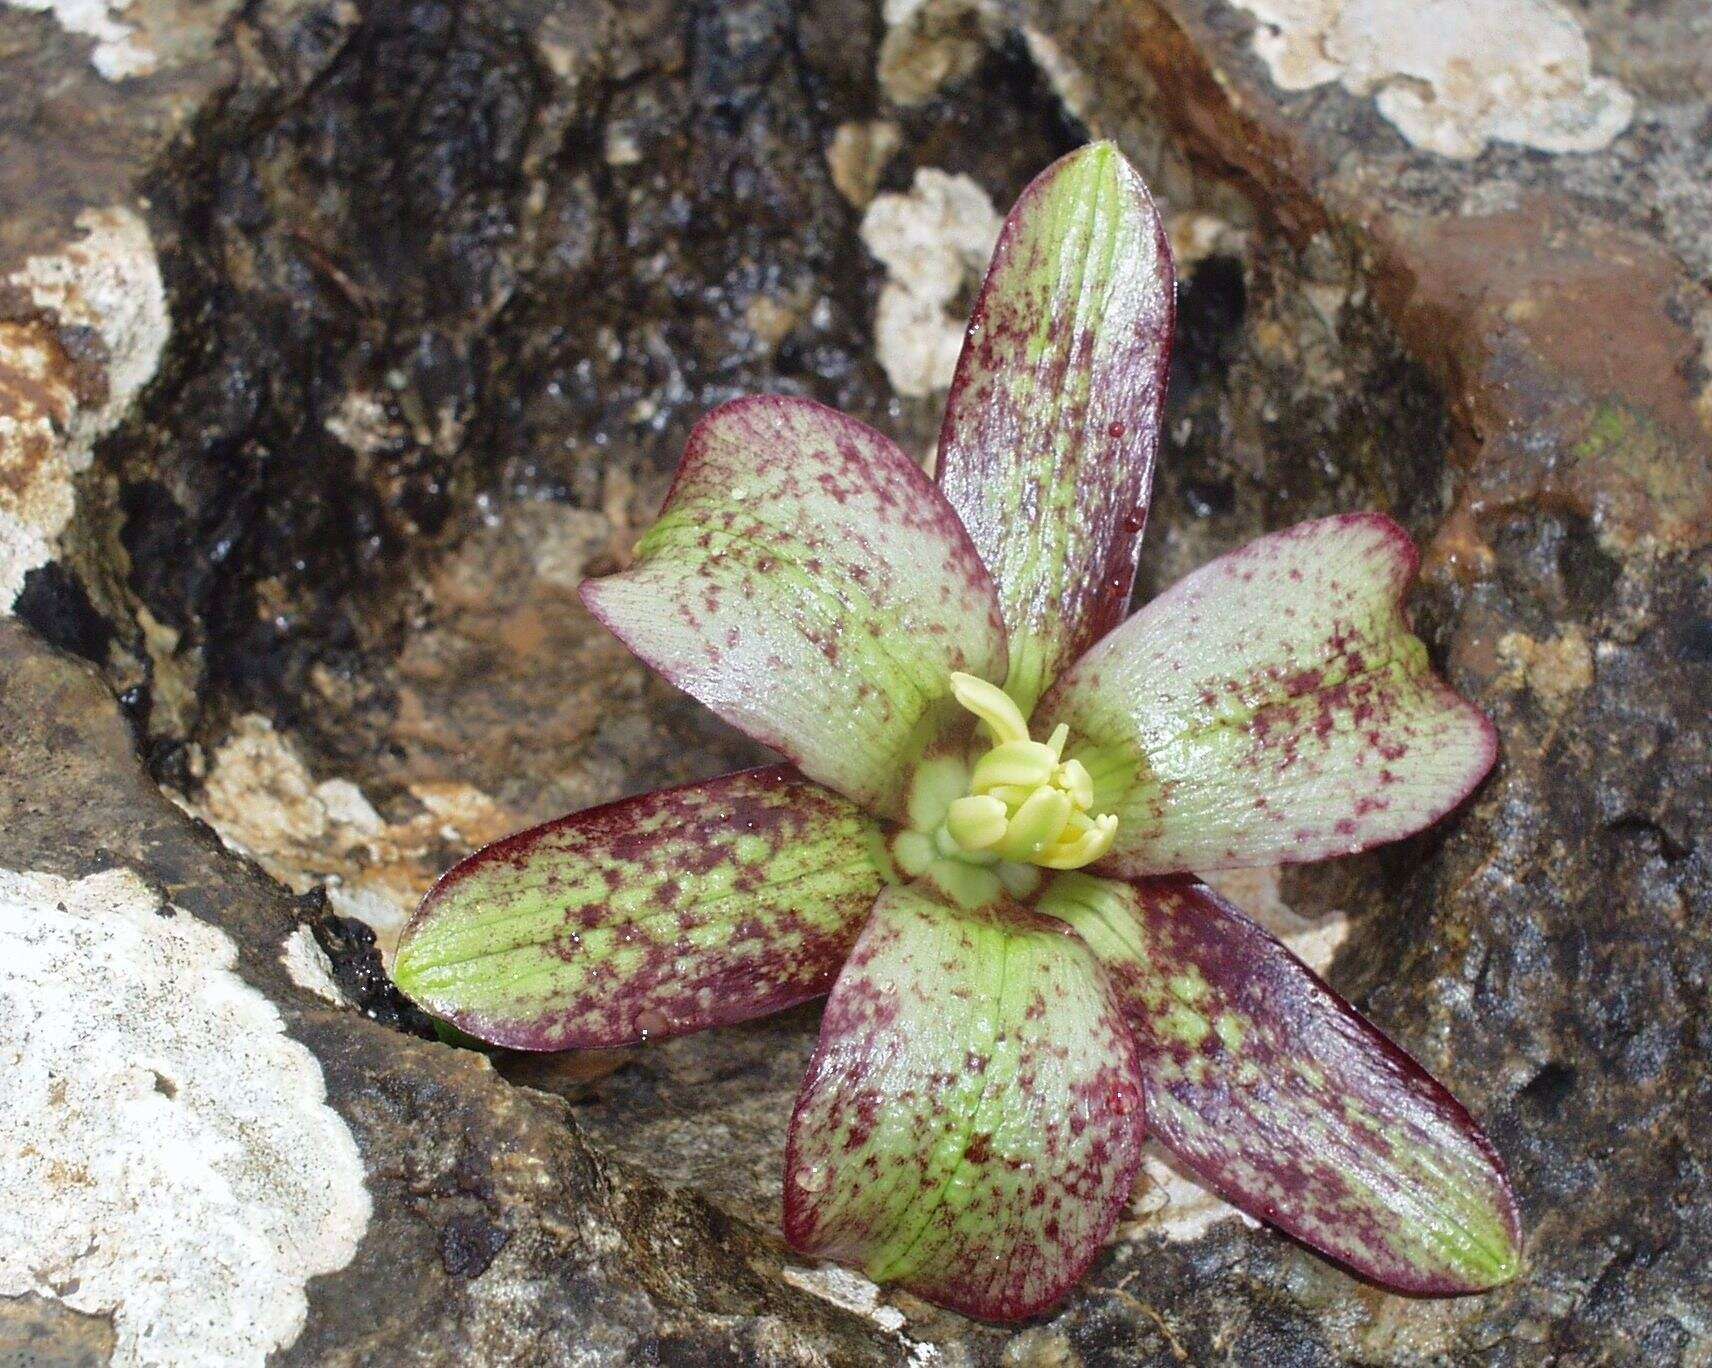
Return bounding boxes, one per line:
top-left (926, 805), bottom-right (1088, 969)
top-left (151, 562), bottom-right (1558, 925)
top-left (392, 765), bottom-right (889, 1050)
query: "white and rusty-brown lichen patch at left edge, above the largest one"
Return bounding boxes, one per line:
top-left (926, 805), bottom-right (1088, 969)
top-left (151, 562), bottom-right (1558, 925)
top-left (0, 207), bottom-right (171, 615)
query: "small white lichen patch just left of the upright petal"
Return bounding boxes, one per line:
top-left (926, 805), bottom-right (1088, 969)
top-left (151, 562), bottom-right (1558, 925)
top-left (861, 166), bottom-right (1000, 399)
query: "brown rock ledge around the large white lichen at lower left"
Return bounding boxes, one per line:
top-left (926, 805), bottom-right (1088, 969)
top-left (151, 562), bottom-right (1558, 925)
top-left (0, 623), bottom-right (897, 1363)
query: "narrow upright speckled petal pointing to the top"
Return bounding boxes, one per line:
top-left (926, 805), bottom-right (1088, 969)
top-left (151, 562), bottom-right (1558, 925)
top-left (938, 142), bottom-right (1176, 712)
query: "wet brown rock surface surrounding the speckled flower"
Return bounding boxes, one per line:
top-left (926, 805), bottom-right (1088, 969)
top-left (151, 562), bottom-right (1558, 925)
top-left (0, 0), bottom-right (1712, 1365)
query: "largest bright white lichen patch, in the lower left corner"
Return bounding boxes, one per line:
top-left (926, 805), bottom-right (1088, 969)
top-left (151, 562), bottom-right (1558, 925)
top-left (0, 870), bottom-right (370, 1365)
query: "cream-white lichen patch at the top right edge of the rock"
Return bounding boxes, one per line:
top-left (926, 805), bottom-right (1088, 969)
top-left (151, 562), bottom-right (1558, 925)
top-left (1234, 0), bottom-right (1635, 158)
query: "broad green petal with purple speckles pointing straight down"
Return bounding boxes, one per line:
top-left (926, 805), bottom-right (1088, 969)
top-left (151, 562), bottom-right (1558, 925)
top-left (784, 885), bottom-right (1145, 1320)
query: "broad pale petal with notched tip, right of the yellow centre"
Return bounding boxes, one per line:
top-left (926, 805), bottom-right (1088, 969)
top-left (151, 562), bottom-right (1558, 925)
top-left (1039, 514), bottom-right (1498, 877)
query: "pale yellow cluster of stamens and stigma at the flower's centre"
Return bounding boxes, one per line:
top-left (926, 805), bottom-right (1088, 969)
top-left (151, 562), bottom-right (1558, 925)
top-left (943, 673), bottom-right (1118, 870)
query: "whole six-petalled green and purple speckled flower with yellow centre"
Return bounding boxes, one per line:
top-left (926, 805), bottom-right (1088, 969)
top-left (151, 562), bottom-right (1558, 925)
top-left (394, 144), bottom-right (1520, 1320)
